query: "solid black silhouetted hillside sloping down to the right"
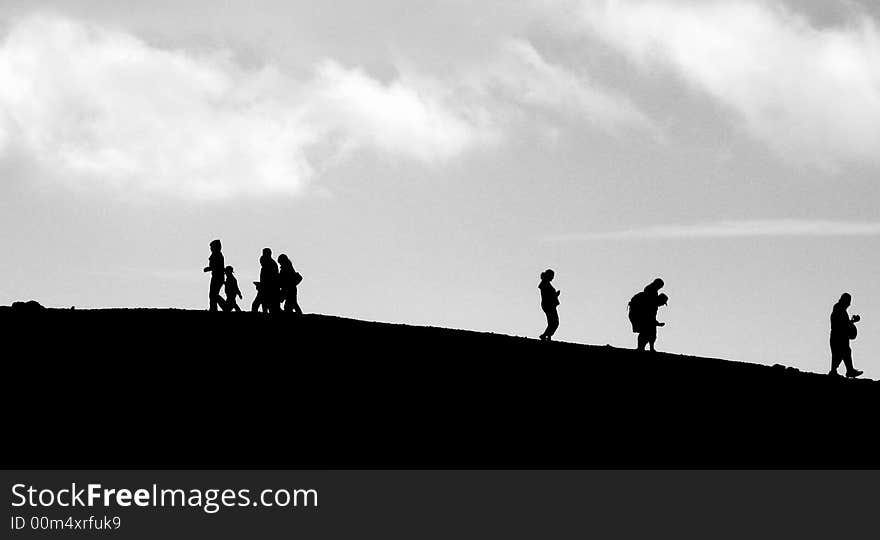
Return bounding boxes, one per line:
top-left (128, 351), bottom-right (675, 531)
top-left (0, 308), bottom-right (880, 468)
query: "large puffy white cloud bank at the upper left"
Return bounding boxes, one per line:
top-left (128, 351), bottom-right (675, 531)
top-left (0, 16), bottom-right (492, 197)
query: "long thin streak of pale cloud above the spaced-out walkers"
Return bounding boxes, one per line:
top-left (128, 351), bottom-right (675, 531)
top-left (546, 219), bottom-right (880, 243)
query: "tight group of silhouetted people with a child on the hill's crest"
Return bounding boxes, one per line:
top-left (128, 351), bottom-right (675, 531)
top-left (204, 240), bottom-right (303, 314)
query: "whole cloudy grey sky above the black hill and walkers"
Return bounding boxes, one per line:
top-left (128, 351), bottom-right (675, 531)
top-left (0, 0), bottom-right (880, 378)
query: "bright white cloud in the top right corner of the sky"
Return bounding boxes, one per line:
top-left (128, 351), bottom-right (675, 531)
top-left (581, 0), bottom-right (880, 167)
